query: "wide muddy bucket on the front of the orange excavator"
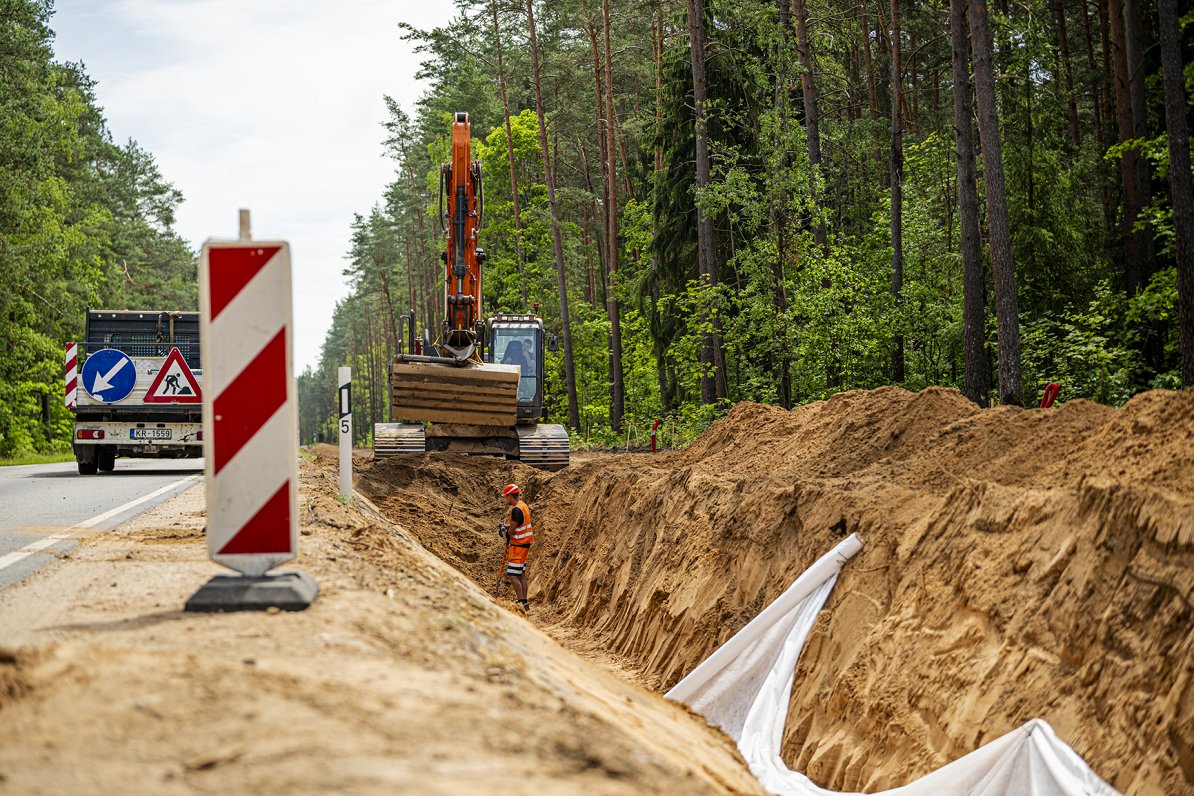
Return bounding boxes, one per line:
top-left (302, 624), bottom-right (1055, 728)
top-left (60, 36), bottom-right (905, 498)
top-left (390, 362), bottom-right (518, 426)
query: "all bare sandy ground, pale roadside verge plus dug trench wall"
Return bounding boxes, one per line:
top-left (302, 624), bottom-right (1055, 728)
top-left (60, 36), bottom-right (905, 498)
top-left (0, 388), bottom-right (1194, 795)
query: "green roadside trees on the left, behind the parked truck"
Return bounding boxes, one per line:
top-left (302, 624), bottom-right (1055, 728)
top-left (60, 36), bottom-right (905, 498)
top-left (0, 0), bottom-right (198, 457)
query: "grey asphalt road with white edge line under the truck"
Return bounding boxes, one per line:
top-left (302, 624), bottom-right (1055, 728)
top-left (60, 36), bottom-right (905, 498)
top-left (0, 458), bottom-right (203, 588)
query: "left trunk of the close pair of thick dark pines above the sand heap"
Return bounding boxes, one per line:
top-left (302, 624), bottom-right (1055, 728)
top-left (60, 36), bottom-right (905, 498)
top-left (949, 0), bottom-right (991, 406)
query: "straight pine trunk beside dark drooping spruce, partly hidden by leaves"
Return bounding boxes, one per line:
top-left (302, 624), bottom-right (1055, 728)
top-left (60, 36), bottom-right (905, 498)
top-left (688, 0), bottom-right (727, 403)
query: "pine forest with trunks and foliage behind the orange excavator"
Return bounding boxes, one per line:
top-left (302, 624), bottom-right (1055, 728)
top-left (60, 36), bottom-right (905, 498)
top-left (300, 0), bottom-right (1194, 445)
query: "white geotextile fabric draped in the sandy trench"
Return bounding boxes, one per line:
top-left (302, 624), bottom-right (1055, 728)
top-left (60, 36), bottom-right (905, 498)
top-left (667, 536), bottom-right (1116, 796)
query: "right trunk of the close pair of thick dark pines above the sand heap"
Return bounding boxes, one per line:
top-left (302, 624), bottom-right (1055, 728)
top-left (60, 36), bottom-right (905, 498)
top-left (966, 0), bottom-right (1023, 406)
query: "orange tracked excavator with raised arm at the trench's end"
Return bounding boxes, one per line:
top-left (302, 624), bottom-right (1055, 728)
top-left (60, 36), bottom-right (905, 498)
top-left (374, 113), bottom-right (570, 470)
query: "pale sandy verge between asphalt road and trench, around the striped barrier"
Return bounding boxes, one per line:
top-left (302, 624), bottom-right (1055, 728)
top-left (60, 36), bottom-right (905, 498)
top-left (0, 463), bottom-right (758, 795)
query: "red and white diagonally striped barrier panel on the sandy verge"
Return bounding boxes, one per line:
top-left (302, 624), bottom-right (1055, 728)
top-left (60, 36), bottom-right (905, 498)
top-left (199, 221), bottom-right (299, 575)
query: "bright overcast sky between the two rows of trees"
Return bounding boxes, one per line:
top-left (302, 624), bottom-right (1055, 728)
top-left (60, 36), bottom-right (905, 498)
top-left (51, 0), bottom-right (453, 372)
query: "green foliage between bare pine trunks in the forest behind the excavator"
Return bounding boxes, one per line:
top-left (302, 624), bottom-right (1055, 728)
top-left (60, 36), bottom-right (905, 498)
top-left (303, 0), bottom-right (1194, 448)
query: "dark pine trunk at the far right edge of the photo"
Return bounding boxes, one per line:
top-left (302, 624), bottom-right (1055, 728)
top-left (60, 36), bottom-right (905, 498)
top-left (1157, 0), bottom-right (1194, 387)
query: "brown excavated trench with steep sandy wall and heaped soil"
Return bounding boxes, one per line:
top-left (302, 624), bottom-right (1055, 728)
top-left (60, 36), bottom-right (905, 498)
top-left (348, 388), bottom-right (1194, 794)
